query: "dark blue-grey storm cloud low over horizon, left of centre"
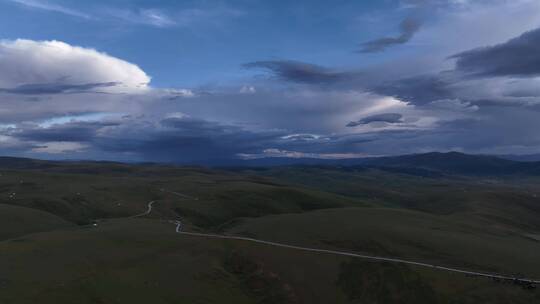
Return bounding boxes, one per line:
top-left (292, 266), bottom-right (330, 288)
top-left (2, 117), bottom-right (280, 162)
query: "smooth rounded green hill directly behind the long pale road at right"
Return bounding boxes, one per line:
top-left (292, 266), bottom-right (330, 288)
top-left (230, 208), bottom-right (540, 277)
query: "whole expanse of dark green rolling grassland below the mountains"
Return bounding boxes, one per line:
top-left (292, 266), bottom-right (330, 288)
top-left (0, 158), bottom-right (540, 304)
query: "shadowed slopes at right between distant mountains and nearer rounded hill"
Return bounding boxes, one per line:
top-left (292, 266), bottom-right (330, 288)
top-left (254, 167), bottom-right (540, 231)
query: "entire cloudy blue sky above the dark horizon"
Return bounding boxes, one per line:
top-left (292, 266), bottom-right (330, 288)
top-left (0, 0), bottom-right (540, 164)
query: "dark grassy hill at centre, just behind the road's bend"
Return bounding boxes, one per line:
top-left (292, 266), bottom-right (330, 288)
top-left (160, 177), bottom-right (367, 229)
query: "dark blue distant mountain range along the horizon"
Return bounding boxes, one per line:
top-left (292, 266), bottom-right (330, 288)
top-left (0, 152), bottom-right (540, 176)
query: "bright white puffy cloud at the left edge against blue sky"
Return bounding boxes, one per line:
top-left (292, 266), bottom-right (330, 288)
top-left (0, 39), bottom-right (150, 92)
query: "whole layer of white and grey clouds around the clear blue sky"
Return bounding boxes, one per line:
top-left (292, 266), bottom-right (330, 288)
top-left (0, 0), bottom-right (540, 163)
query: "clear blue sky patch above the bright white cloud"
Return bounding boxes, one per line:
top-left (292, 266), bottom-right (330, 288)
top-left (0, 0), bottom-right (403, 86)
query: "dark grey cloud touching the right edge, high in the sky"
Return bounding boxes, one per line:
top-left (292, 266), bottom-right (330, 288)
top-left (450, 28), bottom-right (540, 77)
